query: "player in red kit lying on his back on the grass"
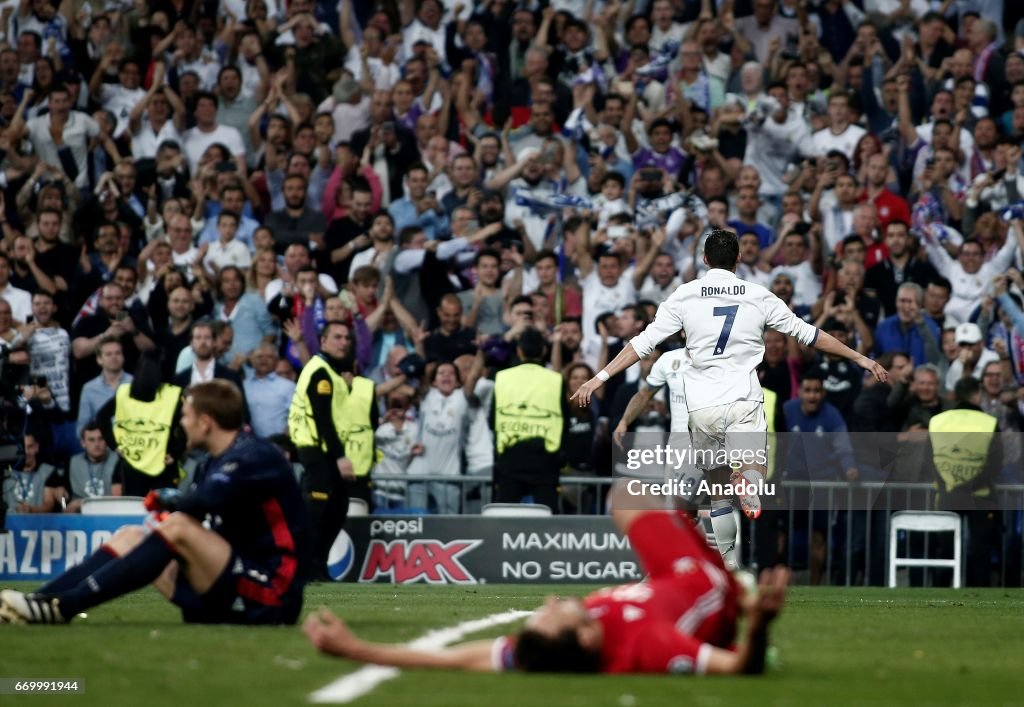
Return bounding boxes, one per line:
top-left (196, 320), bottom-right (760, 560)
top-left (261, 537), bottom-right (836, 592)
top-left (304, 485), bottom-right (790, 674)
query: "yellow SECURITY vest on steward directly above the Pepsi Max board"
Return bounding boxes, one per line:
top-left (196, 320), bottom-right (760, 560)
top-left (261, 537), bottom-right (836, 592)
top-left (495, 364), bottom-right (564, 454)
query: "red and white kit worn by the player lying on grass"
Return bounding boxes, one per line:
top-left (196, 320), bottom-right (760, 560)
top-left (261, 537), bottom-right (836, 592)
top-left (492, 511), bottom-right (739, 673)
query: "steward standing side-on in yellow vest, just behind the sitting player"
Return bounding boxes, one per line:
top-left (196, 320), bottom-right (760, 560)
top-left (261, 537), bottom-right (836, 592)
top-left (288, 322), bottom-right (377, 579)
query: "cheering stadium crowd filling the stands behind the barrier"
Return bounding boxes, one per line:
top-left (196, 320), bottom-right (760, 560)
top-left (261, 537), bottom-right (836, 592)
top-left (0, 0), bottom-right (1024, 549)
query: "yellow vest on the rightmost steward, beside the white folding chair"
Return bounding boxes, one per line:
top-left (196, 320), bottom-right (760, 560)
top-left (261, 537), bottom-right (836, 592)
top-left (928, 410), bottom-right (998, 497)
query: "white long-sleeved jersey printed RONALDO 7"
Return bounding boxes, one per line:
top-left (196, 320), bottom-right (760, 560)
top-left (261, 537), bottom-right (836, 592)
top-left (630, 267), bottom-right (818, 413)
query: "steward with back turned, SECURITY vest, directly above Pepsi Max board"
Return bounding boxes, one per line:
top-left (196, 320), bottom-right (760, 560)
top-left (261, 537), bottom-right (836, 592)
top-left (490, 329), bottom-right (568, 511)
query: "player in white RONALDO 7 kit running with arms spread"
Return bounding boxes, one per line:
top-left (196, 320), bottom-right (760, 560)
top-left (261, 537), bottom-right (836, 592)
top-left (571, 228), bottom-right (888, 566)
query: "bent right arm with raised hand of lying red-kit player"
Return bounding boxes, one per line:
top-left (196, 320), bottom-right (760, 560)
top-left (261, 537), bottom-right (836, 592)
top-left (705, 566), bottom-right (790, 675)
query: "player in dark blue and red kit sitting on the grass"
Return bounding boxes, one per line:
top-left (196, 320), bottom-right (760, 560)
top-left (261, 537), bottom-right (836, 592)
top-left (0, 380), bottom-right (309, 624)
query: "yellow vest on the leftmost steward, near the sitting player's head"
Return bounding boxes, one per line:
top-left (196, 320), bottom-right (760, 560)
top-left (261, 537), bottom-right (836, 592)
top-left (114, 383), bottom-right (181, 476)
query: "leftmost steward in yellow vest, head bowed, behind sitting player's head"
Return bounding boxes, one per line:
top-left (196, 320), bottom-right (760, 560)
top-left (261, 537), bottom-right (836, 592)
top-left (96, 356), bottom-right (185, 496)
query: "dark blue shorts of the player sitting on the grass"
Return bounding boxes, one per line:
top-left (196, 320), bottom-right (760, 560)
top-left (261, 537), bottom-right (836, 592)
top-left (171, 550), bottom-right (302, 625)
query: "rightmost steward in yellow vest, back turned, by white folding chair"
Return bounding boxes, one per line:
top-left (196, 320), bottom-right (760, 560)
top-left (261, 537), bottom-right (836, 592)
top-left (928, 376), bottom-right (1002, 587)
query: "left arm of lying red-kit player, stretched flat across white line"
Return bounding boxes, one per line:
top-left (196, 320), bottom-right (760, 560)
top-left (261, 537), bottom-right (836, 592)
top-left (302, 609), bottom-right (494, 672)
